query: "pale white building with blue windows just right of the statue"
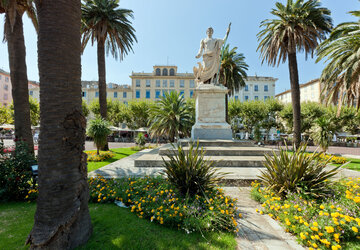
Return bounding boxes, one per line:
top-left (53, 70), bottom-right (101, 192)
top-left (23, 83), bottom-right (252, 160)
top-left (230, 76), bottom-right (278, 102)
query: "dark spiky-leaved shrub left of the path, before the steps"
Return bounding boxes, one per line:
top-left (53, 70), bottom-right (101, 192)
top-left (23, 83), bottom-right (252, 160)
top-left (163, 144), bottom-right (222, 197)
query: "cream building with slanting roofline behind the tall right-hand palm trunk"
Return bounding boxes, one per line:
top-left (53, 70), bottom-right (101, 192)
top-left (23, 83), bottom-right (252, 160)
top-left (275, 79), bottom-right (322, 103)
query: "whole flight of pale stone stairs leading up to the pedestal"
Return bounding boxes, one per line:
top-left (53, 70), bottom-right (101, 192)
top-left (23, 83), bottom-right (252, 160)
top-left (134, 140), bottom-right (278, 182)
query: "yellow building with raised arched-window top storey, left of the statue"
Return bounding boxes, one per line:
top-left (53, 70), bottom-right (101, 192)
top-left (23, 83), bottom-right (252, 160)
top-left (130, 66), bottom-right (196, 101)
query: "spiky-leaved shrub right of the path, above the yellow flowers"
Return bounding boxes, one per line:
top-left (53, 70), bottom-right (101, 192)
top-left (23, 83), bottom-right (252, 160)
top-left (259, 144), bottom-right (339, 197)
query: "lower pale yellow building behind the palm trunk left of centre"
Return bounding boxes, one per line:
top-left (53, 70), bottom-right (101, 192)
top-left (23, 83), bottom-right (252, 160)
top-left (81, 81), bottom-right (132, 104)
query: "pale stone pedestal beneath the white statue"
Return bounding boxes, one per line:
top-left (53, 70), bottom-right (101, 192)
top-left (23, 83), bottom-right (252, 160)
top-left (191, 84), bottom-right (232, 140)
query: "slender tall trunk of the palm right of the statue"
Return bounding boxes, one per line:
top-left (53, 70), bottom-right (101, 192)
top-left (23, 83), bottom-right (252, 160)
top-left (289, 52), bottom-right (301, 147)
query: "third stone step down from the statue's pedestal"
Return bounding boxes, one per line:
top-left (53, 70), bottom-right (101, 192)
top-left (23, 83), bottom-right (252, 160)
top-left (135, 154), bottom-right (265, 168)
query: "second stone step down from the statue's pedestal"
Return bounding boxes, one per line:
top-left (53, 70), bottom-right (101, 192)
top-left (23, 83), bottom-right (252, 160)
top-left (159, 145), bottom-right (278, 156)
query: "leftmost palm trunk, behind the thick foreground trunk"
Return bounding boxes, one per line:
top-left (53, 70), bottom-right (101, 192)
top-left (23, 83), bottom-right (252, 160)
top-left (5, 12), bottom-right (34, 153)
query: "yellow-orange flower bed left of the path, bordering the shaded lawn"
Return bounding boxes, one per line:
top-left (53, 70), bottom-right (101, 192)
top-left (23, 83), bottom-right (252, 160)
top-left (89, 176), bottom-right (241, 233)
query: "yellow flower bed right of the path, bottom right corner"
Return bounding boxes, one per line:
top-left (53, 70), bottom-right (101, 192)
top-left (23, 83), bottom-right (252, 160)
top-left (251, 178), bottom-right (360, 249)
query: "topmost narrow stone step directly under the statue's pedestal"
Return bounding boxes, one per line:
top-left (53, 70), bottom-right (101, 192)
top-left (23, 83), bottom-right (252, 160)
top-left (178, 139), bottom-right (255, 147)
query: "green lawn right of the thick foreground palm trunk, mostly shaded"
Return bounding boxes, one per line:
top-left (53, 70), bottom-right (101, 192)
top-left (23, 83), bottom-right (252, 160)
top-left (79, 204), bottom-right (236, 249)
